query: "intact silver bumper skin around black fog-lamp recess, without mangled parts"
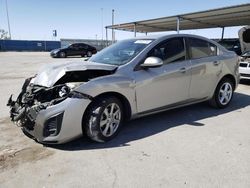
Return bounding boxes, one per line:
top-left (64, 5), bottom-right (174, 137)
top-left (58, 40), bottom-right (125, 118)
top-left (23, 98), bottom-right (91, 144)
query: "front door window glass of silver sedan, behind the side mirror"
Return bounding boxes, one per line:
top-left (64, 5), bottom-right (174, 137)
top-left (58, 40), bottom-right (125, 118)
top-left (148, 38), bottom-right (186, 64)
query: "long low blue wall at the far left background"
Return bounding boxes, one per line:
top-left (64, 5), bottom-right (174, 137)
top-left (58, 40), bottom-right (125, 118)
top-left (0, 40), bottom-right (61, 51)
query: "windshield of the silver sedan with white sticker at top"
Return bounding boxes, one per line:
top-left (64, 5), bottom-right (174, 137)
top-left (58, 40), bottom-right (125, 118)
top-left (89, 39), bottom-right (153, 65)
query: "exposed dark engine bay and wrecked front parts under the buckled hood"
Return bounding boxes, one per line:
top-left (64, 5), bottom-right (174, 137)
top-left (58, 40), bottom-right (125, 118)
top-left (7, 70), bottom-right (114, 130)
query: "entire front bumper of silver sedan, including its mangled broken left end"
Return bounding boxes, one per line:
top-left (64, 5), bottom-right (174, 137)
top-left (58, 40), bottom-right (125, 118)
top-left (7, 78), bottom-right (91, 144)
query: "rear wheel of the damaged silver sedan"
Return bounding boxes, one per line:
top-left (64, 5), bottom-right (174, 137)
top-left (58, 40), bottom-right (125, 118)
top-left (209, 78), bottom-right (234, 108)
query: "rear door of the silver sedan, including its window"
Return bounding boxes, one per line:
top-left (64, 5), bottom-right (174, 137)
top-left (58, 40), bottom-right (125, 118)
top-left (186, 37), bottom-right (222, 100)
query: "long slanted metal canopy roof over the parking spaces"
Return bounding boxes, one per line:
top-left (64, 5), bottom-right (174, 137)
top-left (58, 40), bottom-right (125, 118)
top-left (106, 3), bottom-right (250, 35)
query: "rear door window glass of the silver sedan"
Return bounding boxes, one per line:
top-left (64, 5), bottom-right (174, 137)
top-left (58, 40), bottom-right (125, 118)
top-left (187, 38), bottom-right (217, 59)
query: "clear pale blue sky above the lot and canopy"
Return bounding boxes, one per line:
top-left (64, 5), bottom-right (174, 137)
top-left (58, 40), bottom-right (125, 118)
top-left (0, 0), bottom-right (250, 40)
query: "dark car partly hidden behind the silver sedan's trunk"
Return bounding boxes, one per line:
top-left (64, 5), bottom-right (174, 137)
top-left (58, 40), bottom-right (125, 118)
top-left (217, 39), bottom-right (242, 55)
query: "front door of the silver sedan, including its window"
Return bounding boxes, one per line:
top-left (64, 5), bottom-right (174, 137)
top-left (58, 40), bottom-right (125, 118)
top-left (135, 37), bottom-right (191, 113)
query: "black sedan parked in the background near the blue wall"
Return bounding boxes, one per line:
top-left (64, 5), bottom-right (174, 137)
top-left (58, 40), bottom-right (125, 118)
top-left (50, 43), bottom-right (97, 58)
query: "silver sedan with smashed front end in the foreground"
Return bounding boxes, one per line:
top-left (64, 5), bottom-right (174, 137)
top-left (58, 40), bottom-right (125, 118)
top-left (8, 34), bottom-right (239, 144)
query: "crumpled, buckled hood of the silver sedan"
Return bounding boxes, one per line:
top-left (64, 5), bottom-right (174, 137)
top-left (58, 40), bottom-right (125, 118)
top-left (31, 61), bottom-right (117, 87)
